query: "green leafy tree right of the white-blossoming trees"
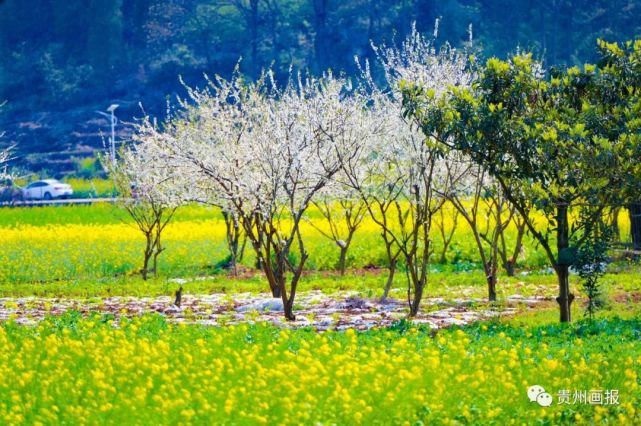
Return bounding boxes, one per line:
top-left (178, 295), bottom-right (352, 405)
top-left (404, 51), bottom-right (624, 322)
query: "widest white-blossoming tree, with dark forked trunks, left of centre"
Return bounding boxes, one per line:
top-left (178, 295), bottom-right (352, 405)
top-left (144, 70), bottom-right (373, 320)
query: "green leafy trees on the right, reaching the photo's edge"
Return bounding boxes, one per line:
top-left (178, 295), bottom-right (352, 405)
top-left (404, 41), bottom-right (641, 322)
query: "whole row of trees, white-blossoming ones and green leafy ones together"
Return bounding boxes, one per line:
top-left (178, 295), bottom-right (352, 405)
top-left (110, 29), bottom-right (640, 321)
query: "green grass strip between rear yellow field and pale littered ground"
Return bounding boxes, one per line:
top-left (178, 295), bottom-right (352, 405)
top-left (0, 271), bottom-right (564, 298)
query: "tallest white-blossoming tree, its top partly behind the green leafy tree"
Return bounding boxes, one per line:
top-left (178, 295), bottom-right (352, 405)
top-left (343, 27), bottom-right (472, 316)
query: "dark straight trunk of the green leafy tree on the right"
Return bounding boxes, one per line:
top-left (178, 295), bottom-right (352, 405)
top-left (555, 204), bottom-right (574, 322)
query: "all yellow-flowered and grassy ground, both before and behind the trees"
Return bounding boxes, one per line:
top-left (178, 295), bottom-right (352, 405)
top-left (0, 204), bottom-right (641, 425)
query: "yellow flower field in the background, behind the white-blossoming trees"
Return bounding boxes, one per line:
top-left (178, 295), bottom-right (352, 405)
top-left (0, 204), bottom-right (556, 283)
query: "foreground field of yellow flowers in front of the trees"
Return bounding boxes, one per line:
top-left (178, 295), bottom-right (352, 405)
top-left (0, 315), bottom-right (641, 425)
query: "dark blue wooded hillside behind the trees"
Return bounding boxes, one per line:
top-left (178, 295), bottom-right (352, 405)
top-left (0, 0), bottom-right (641, 162)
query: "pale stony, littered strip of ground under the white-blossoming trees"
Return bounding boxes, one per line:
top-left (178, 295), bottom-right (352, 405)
top-left (0, 288), bottom-right (553, 331)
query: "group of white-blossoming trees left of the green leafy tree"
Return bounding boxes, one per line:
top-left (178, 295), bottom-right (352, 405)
top-left (117, 25), bottom-right (532, 320)
